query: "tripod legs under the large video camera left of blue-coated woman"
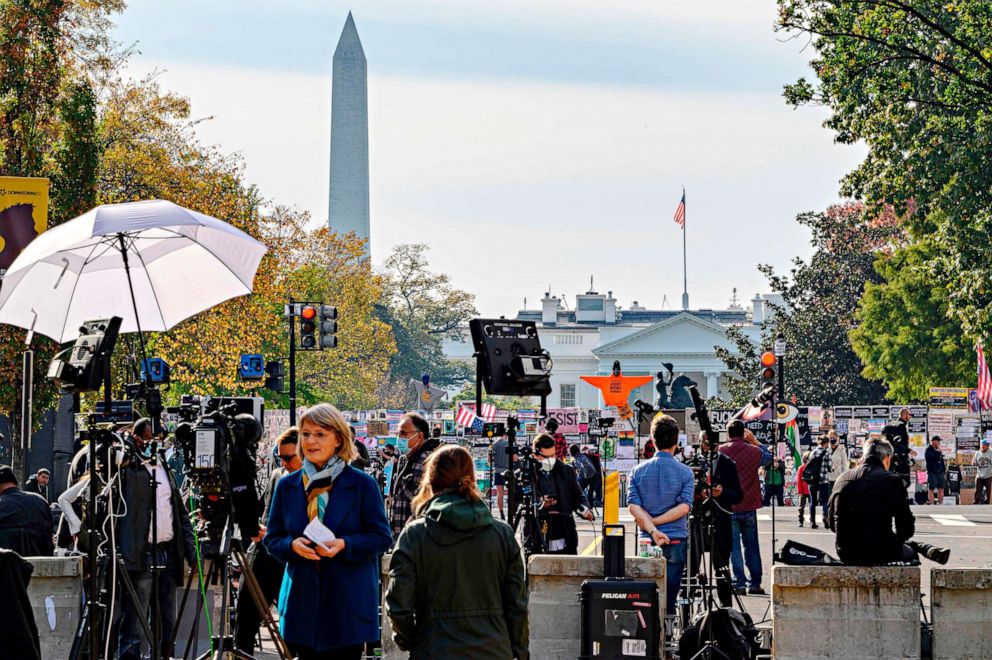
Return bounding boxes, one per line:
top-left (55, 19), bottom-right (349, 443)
top-left (170, 502), bottom-right (293, 660)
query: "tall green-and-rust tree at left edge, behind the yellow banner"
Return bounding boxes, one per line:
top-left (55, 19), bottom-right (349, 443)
top-left (0, 0), bottom-right (123, 474)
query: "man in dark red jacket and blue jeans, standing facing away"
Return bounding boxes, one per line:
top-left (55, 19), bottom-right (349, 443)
top-left (720, 419), bottom-right (772, 595)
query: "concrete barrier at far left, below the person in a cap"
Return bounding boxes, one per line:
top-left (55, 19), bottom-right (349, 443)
top-left (25, 557), bottom-right (83, 658)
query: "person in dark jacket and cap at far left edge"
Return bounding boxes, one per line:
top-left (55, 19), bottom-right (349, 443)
top-left (0, 465), bottom-right (55, 557)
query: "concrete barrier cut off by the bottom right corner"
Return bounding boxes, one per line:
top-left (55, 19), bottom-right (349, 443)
top-left (930, 568), bottom-right (992, 660)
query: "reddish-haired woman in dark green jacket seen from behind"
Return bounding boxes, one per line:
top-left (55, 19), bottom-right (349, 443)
top-left (386, 445), bottom-right (528, 660)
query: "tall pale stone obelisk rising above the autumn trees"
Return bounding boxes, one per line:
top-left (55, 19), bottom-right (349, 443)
top-left (327, 12), bottom-right (369, 256)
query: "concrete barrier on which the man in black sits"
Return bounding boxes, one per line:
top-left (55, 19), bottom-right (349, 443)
top-left (772, 566), bottom-right (920, 660)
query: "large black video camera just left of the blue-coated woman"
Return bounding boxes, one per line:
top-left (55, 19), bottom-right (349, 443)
top-left (169, 397), bottom-right (262, 556)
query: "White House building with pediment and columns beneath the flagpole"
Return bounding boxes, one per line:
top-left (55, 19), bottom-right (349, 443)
top-left (444, 284), bottom-right (781, 408)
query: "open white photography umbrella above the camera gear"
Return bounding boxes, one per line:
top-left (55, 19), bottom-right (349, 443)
top-left (0, 199), bottom-right (266, 343)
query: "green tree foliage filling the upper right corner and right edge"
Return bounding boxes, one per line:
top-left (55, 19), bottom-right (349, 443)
top-left (778, 0), bottom-right (992, 376)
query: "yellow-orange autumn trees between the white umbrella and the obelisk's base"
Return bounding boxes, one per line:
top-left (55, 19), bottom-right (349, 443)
top-left (99, 79), bottom-right (394, 407)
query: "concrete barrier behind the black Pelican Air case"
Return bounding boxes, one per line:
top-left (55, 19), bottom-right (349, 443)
top-left (527, 555), bottom-right (665, 660)
